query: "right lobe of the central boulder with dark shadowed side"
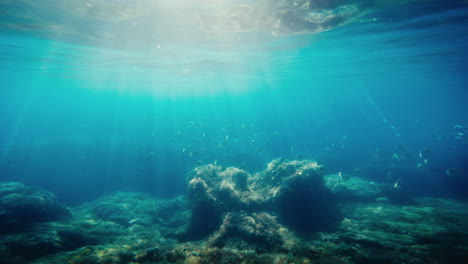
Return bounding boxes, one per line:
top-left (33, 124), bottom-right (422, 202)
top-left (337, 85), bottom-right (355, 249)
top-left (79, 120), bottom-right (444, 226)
top-left (255, 158), bottom-right (338, 232)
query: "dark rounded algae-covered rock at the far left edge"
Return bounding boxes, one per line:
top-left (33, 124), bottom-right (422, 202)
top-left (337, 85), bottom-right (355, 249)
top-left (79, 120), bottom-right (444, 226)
top-left (0, 182), bottom-right (70, 233)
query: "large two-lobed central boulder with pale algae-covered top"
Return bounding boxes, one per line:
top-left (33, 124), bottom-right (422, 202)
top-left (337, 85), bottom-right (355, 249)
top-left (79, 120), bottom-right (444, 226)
top-left (187, 159), bottom-right (337, 242)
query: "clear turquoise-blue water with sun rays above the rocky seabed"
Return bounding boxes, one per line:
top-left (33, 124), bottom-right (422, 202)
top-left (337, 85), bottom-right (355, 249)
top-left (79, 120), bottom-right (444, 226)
top-left (0, 1), bottom-right (468, 205)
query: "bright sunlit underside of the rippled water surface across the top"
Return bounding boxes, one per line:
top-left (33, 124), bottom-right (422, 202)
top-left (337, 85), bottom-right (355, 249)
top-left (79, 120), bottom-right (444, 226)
top-left (0, 0), bottom-right (468, 96)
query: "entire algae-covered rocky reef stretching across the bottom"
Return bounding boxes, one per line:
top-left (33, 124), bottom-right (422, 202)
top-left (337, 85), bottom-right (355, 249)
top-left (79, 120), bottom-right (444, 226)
top-left (0, 159), bottom-right (468, 264)
